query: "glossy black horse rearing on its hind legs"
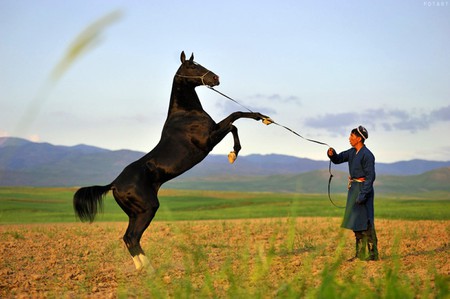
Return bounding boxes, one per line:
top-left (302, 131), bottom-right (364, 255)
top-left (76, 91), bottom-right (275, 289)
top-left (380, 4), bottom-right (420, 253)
top-left (73, 52), bottom-right (270, 270)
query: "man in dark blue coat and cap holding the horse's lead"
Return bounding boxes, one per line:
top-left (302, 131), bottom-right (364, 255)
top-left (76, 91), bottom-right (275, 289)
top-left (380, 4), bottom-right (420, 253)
top-left (327, 126), bottom-right (378, 261)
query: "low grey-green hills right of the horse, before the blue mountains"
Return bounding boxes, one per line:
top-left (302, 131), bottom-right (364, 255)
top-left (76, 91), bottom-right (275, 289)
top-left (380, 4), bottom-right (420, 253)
top-left (165, 167), bottom-right (450, 194)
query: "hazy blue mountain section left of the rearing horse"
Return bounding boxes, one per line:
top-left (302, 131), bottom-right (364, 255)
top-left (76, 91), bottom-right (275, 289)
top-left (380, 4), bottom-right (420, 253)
top-left (0, 138), bottom-right (143, 186)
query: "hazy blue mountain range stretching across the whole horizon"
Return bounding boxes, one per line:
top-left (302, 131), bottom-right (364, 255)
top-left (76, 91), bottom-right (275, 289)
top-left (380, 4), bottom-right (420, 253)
top-left (0, 137), bottom-right (450, 193)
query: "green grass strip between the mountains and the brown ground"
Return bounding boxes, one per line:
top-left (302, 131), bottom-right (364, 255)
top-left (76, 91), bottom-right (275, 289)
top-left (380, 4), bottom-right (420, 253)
top-left (0, 187), bottom-right (450, 223)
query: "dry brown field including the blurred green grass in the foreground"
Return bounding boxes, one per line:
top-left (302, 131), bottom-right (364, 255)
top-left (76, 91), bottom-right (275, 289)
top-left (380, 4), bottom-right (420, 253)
top-left (0, 218), bottom-right (450, 298)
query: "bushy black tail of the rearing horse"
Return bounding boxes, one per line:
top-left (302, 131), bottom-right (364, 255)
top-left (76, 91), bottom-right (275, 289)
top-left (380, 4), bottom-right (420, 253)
top-left (73, 184), bottom-right (112, 222)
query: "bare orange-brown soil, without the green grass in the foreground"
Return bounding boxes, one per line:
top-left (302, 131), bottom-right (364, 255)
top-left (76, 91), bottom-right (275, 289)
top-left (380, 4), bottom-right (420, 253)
top-left (0, 218), bottom-right (450, 298)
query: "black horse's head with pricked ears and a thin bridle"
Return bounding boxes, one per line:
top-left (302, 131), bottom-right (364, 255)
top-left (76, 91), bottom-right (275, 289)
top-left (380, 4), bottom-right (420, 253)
top-left (175, 51), bottom-right (220, 87)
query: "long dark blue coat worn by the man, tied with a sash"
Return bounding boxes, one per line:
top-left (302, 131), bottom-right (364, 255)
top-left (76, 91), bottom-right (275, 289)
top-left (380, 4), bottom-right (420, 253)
top-left (329, 146), bottom-right (375, 231)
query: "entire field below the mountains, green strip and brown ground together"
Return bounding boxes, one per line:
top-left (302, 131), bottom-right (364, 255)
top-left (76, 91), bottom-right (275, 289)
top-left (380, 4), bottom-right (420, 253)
top-left (0, 188), bottom-right (450, 298)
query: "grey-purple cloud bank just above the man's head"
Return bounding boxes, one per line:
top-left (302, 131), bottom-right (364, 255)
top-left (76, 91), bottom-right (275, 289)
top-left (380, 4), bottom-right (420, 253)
top-left (305, 105), bottom-right (450, 135)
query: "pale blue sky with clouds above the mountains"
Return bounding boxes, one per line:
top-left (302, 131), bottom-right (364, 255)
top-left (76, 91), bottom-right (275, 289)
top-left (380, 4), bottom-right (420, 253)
top-left (0, 0), bottom-right (450, 163)
